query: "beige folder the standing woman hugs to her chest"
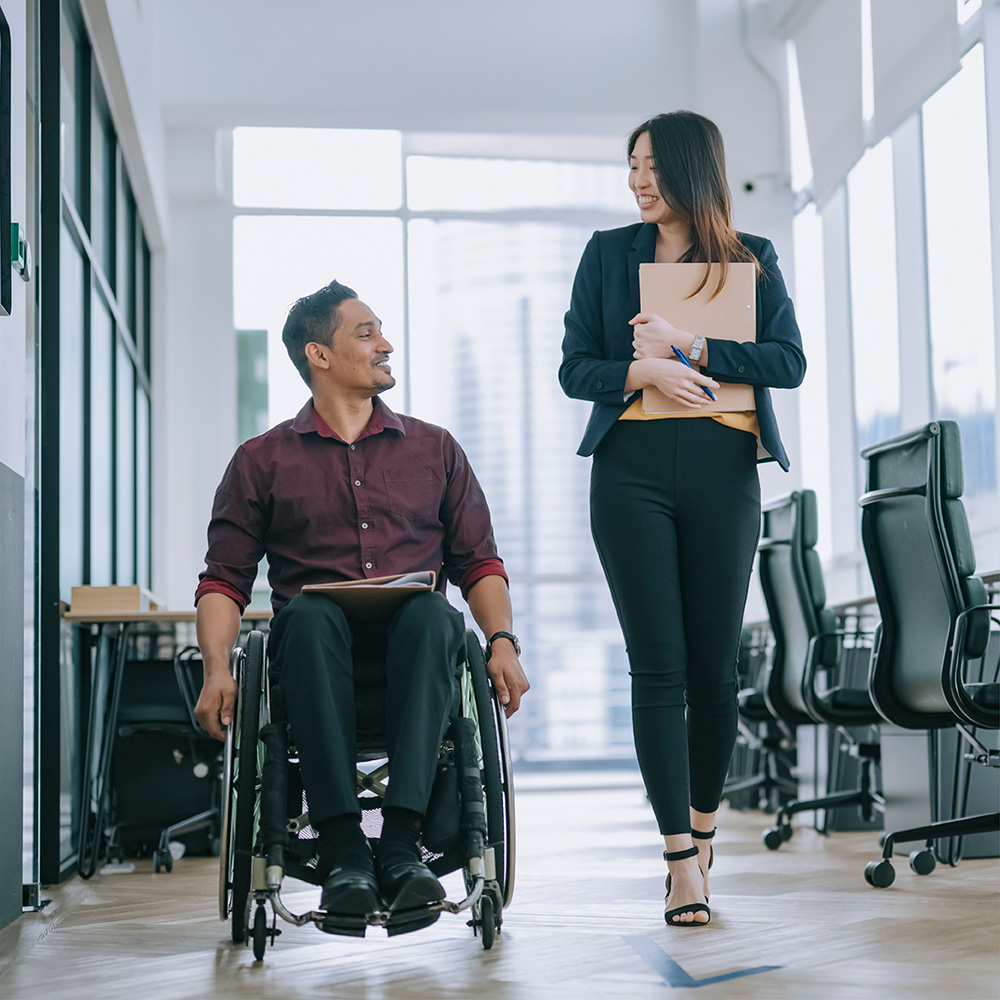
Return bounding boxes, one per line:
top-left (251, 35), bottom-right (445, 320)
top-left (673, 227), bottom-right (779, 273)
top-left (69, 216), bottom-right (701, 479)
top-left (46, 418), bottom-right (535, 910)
top-left (639, 261), bottom-right (757, 414)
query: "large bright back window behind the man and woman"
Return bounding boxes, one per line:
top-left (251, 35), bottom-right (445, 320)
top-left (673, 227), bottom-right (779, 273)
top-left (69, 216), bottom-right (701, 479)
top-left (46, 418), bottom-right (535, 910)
top-left (234, 129), bottom-right (635, 761)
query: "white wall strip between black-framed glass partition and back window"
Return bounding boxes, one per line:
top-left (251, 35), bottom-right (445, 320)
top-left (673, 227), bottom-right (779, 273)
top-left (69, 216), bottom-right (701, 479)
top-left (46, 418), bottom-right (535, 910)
top-left (158, 129), bottom-right (237, 609)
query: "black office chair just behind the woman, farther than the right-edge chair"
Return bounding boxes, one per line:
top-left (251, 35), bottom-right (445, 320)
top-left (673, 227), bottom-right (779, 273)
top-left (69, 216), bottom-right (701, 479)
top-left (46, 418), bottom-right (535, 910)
top-left (759, 490), bottom-right (885, 850)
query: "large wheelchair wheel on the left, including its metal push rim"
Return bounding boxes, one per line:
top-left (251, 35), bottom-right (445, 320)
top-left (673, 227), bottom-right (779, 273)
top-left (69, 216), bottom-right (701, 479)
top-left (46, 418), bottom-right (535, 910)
top-left (219, 632), bottom-right (264, 944)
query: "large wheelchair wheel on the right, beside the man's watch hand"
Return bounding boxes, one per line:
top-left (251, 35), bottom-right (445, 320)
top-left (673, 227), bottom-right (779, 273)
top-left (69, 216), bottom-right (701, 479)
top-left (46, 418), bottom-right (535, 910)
top-left (466, 630), bottom-right (514, 907)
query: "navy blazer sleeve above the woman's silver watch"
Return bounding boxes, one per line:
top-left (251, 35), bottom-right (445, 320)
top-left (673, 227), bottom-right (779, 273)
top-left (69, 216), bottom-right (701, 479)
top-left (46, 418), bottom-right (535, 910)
top-left (702, 240), bottom-right (806, 389)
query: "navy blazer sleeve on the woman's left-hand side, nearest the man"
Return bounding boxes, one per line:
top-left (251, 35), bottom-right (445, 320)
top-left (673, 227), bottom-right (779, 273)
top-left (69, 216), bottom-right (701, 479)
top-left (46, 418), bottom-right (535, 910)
top-left (559, 233), bottom-right (632, 404)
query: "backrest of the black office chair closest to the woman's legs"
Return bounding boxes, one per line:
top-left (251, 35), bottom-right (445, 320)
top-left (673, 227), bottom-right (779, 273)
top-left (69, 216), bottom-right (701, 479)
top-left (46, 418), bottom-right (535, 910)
top-left (758, 490), bottom-right (837, 726)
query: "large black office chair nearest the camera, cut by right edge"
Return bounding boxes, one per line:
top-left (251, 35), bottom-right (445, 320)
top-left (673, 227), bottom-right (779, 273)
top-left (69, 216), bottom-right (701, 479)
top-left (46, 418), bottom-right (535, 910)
top-left (859, 420), bottom-right (1000, 888)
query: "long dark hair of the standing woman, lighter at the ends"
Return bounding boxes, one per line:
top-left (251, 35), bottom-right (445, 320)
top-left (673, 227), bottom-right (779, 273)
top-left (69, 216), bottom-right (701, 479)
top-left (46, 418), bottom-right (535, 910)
top-left (628, 111), bottom-right (760, 298)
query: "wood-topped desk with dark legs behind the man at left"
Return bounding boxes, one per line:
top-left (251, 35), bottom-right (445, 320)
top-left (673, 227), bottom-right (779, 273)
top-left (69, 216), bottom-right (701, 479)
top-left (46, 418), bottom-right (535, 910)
top-left (63, 611), bottom-right (271, 878)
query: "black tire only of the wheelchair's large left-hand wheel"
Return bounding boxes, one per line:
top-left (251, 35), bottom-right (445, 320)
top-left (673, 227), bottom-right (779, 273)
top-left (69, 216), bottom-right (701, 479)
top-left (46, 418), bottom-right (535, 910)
top-left (225, 632), bottom-right (264, 944)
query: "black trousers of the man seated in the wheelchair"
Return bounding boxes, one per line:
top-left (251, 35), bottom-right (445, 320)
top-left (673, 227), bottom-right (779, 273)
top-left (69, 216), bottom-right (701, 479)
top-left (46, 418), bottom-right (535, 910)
top-left (270, 592), bottom-right (465, 826)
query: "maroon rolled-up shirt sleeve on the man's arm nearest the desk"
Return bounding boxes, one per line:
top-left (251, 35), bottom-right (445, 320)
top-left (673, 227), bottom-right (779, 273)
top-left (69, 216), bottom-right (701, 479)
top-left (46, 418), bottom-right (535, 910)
top-left (194, 446), bottom-right (265, 614)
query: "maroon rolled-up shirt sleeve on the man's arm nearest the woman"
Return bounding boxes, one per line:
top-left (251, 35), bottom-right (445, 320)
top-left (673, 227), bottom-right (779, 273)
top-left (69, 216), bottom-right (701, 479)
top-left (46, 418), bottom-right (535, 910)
top-left (440, 433), bottom-right (507, 598)
